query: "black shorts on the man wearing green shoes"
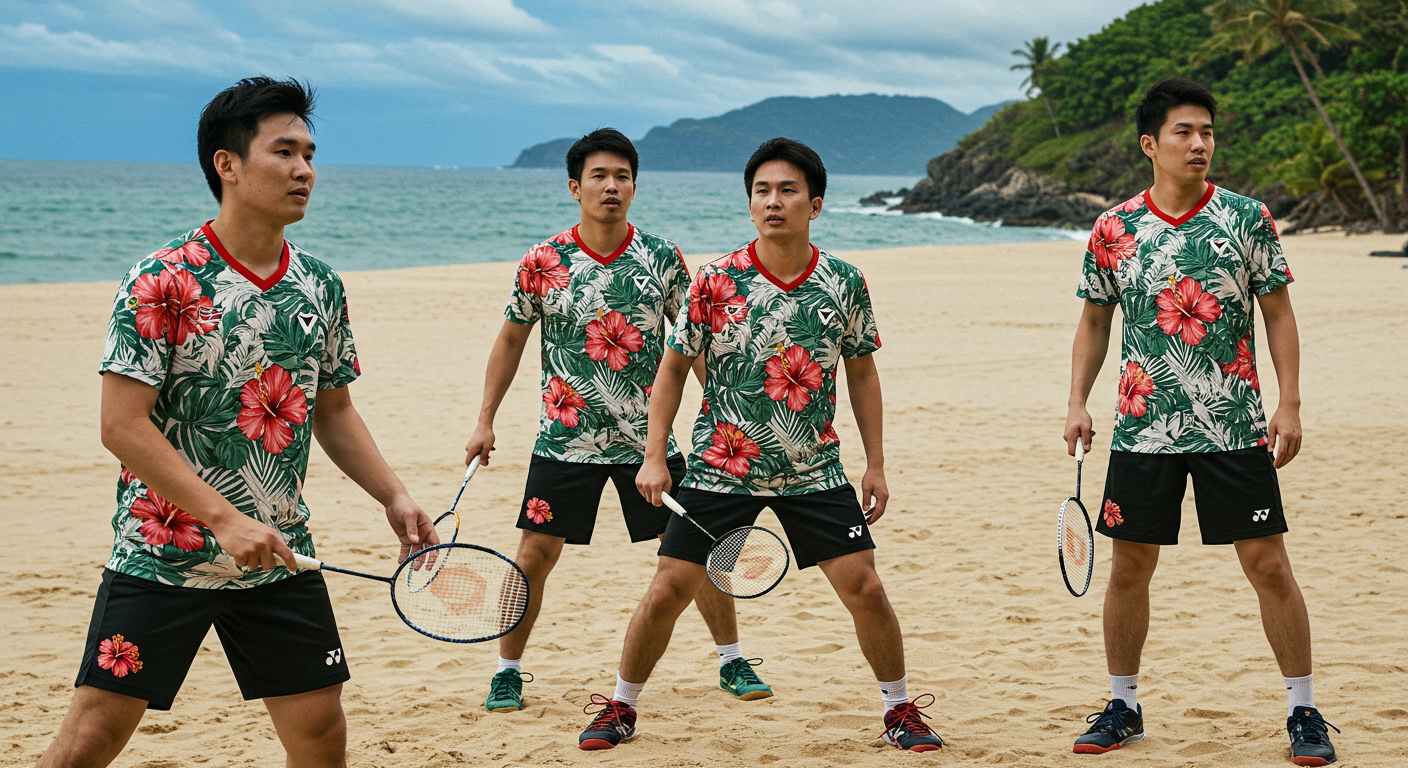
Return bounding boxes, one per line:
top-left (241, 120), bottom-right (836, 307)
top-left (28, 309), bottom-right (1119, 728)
top-left (518, 454), bottom-right (684, 544)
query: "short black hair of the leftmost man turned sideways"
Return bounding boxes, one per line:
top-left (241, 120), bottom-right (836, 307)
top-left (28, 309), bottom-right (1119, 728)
top-left (196, 75), bottom-right (318, 202)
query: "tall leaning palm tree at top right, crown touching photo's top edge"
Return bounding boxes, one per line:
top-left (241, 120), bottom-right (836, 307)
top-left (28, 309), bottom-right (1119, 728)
top-left (1204, 0), bottom-right (1391, 230)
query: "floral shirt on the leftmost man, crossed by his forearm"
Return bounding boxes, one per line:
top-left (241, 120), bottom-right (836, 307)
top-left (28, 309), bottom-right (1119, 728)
top-left (99, 224), bottom-right (359, 589)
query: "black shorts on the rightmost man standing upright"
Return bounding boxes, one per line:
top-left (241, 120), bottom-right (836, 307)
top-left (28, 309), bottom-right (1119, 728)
top-left (1090, 445), bottom-right (1287, 544)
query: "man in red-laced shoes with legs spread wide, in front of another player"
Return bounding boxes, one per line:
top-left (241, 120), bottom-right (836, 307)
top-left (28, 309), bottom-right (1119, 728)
top-left (577, 138), bottom-right (942, 751)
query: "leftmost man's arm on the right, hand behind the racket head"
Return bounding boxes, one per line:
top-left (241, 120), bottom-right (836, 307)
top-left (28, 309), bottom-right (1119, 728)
top-left (313, 386), bottom-right (439, 559)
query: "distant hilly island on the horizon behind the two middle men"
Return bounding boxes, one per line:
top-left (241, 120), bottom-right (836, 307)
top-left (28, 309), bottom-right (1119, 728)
top-left (513, 93), bottom-right (1004, 176)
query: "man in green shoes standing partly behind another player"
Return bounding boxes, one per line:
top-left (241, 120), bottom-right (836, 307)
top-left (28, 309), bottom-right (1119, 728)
top-left (465, 128), bottom-right (773, 712)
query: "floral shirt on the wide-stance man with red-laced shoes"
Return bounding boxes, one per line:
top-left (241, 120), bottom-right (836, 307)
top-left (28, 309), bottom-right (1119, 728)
top-left (669, 241), bottom-right (880, 496)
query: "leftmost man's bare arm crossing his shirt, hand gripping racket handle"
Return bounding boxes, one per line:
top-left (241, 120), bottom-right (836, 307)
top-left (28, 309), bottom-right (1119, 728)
top-left (101, 372), bottom-right (294, 571)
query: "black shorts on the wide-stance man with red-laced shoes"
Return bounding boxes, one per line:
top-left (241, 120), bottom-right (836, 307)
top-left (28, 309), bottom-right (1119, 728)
top-left (660, 483), bottom-right (876, 568)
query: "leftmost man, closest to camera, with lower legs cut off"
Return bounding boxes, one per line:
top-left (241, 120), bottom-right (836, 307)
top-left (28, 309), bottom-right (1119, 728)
top-left (39, 78), bottom-right (436, 767)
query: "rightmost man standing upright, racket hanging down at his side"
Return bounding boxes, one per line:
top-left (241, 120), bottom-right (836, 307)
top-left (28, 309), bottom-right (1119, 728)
top-left (1064, 79), bottom-right (1335, 765)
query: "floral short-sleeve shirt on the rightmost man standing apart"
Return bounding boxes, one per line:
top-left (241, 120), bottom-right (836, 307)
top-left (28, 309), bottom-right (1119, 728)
top-left (1076, 183), bottom-right (1293, 454)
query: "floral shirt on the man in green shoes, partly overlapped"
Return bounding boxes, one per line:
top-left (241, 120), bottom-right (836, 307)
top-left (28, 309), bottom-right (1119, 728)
top-left (504, 225), bottom-right (689, 464)
